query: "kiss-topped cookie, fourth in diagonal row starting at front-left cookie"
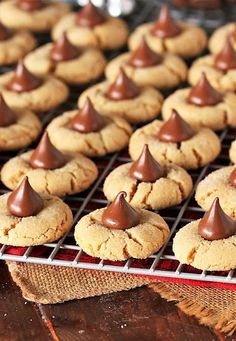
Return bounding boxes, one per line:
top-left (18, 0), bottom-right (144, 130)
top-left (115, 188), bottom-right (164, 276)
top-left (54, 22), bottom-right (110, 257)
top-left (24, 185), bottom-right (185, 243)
top-left (78, 69), bottom-right (163, 123)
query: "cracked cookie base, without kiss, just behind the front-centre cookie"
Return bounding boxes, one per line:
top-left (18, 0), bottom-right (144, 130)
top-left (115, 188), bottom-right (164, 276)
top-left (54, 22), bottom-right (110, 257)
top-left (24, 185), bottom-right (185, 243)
top-left (103, 163), bottom-right (193, 210)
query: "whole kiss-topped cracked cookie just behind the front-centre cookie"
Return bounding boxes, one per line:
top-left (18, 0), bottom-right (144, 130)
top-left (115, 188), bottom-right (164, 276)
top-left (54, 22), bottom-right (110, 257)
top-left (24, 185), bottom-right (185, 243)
top-left (103, 146), bottom-right (193, 210)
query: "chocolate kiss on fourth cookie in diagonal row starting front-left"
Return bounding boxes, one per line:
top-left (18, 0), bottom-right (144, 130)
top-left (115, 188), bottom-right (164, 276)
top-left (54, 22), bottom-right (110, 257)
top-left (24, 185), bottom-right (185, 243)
top-left (106, 68), bottom-right (140, 101)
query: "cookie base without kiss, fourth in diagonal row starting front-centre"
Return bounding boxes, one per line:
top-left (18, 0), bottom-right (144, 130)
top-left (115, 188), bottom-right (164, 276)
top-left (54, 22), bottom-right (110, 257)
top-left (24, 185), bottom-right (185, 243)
top-left (162, 88), bottom-right (236, 130)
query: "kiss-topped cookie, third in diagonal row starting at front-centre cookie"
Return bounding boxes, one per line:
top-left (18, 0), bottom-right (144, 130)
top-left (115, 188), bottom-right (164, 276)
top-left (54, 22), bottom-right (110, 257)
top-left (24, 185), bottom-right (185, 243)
top-left (129, 111), bottom-right (221, 169)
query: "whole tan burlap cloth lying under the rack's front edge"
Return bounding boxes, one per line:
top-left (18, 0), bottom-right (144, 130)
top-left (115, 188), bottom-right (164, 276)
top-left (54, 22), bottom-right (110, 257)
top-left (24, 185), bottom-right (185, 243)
top-left (7, 262), bottom-right (236, 335)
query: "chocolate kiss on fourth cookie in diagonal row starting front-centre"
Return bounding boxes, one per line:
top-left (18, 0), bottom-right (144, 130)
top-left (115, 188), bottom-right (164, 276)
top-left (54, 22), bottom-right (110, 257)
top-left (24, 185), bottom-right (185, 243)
top-left (187, 72), bottom-right (222, 107)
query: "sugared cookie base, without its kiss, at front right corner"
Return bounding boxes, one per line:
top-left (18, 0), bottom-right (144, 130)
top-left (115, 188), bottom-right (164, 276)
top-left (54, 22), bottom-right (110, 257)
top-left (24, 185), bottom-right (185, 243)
top-left (173, 220), bottom-right (236, 271)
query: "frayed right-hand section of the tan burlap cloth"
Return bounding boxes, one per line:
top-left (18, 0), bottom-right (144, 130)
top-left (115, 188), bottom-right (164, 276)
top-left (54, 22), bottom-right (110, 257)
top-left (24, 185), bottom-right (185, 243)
top-left (149, 282), bottom-right (236, 335)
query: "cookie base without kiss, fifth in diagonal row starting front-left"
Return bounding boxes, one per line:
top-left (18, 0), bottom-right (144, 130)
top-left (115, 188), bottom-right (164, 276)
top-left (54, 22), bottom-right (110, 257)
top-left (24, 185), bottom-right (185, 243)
top-left (105, 52), bottom-right (187, 89)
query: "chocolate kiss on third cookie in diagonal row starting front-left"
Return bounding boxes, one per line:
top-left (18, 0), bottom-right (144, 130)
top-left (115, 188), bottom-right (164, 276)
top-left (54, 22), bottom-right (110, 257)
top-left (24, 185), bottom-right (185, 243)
top-left (71, 98), bottom-right (104, 133)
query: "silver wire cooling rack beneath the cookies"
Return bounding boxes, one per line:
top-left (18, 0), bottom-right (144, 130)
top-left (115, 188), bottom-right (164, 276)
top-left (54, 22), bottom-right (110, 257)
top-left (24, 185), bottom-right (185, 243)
top-left (0, 0), bottom-right (236, 284)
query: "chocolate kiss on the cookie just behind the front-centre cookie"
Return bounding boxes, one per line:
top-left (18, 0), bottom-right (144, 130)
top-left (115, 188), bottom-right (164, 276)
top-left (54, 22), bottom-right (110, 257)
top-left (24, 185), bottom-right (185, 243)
top-left (129, 144), bottom-right (165, 182)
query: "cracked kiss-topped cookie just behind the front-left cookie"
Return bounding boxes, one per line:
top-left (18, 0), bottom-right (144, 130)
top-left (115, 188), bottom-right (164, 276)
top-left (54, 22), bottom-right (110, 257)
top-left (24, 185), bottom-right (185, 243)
top-left (1, 133), bottom-right (98, 197)
